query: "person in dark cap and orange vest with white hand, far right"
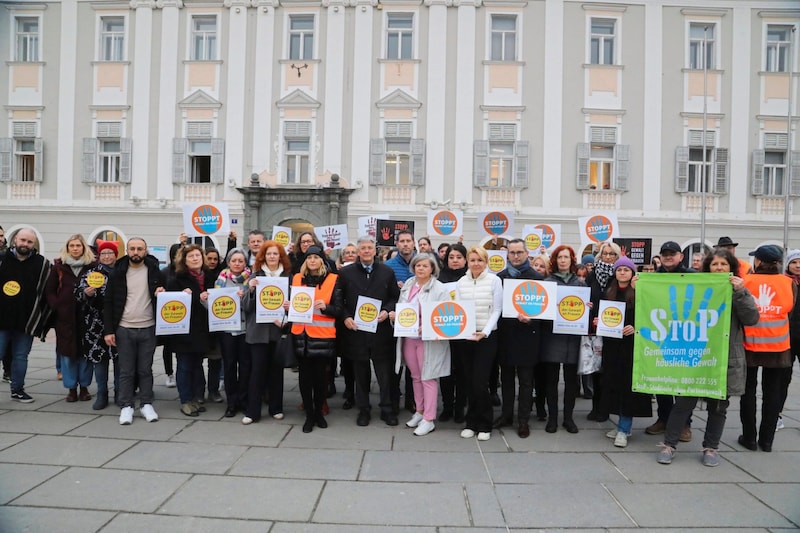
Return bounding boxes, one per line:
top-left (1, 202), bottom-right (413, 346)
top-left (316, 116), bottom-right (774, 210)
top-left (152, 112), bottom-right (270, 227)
top-left (739, 245), bottom-right (797, 452)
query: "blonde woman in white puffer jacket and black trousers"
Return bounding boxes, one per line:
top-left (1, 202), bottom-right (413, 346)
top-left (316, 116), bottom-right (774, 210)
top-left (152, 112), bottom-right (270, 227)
top-left (452, 246), bottom-right (503, 440)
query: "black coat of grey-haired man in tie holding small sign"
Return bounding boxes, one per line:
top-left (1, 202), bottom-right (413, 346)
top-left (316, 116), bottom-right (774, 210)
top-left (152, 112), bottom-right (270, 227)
top-left (339, 262), bottom-right (400, 361)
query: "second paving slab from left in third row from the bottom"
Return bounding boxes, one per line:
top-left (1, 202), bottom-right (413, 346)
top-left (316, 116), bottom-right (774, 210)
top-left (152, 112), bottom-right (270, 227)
top-left (104, 442), bottom-right (246, 474)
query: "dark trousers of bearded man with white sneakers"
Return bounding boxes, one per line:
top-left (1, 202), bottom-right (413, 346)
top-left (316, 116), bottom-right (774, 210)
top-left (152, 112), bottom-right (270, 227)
top-left (115, 326), bottom-right (156, 407)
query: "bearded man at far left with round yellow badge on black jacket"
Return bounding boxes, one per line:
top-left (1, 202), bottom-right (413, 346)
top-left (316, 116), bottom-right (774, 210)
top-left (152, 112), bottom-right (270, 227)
top-left (0, 228), bottom-right (50, 403)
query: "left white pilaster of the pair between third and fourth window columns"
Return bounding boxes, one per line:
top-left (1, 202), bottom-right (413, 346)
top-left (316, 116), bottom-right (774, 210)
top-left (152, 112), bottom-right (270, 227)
top-left (222, 0), bottom-right (251, 195)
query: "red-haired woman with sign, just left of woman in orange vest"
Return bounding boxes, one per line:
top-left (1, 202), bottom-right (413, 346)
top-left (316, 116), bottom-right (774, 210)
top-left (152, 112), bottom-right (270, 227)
top-left (242, 241), bottom-right (292, 425)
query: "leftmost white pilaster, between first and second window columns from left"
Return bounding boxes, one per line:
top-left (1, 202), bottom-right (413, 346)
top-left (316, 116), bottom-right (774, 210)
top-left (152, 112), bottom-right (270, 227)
top-left (55, 0), bottom-right (80, 201)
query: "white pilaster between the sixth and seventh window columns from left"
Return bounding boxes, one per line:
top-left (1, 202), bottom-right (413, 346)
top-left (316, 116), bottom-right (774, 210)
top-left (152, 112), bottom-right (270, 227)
top-left (542, 0), bottom-right (565, 207)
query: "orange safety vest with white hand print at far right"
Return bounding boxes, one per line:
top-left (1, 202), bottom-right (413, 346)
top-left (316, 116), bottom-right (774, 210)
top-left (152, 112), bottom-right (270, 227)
top-left (744, 274), bottom-right (794, 352)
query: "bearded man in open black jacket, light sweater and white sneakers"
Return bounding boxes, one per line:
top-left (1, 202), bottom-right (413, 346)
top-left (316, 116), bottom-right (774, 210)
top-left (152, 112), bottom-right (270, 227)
top-left (103, 237), bottom-right (164, 425)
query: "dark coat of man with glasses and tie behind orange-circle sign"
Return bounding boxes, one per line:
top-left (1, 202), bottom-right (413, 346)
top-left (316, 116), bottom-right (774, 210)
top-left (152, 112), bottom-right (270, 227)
top-left (497, 268), bottom-right (544, 366)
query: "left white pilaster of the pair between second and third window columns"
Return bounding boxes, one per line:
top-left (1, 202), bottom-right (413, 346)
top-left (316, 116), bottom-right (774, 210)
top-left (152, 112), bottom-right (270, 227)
top-left (127, 1), bottom-right (153, 198)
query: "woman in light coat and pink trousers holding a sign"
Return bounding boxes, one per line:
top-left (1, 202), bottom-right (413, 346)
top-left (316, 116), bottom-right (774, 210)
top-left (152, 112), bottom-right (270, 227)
top-left (389, 252), bottom-right (450, 437)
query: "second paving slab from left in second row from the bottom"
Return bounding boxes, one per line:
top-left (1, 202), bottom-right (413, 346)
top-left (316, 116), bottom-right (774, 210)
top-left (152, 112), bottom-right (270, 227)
top-left (14, 467), bottom-right (189, 513)
